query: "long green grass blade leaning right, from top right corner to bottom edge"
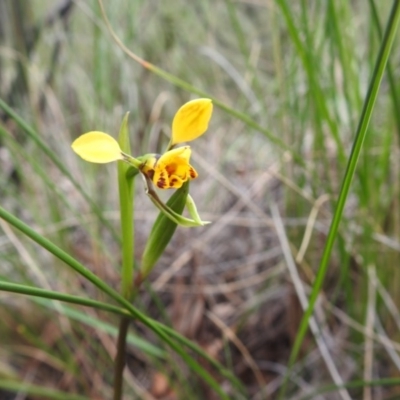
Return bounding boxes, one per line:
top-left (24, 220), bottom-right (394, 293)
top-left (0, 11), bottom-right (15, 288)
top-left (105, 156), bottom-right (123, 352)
top-left (279, 0), bottom-right (400, 399)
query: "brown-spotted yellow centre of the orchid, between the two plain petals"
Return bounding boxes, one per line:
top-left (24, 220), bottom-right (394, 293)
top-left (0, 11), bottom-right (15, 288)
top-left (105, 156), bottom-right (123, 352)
top-left (139, 146), bottom-right (197, 189)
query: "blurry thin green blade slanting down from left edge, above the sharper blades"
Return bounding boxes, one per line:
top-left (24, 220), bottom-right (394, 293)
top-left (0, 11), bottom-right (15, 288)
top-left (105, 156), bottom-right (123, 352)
top-left (0, 98), bottom-right (120, 242)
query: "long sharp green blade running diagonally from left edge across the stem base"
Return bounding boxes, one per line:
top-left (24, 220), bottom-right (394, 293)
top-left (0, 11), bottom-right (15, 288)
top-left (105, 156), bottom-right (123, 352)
top-left (0, 206), bottom-right (229, 400)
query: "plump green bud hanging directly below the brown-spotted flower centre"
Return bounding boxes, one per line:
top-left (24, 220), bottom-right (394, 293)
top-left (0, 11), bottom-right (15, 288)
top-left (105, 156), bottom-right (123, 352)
top-left (141, 182), bottom-right (189, 278)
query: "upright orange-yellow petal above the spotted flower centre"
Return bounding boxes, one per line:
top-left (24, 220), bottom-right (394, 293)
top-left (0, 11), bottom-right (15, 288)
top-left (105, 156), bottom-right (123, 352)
top-left (171, 99), bottom-right (213, 146)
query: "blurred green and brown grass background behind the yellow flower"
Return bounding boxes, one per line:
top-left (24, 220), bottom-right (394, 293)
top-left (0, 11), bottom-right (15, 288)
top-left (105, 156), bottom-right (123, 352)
top-left (0, 0), bottom-right (400, 399)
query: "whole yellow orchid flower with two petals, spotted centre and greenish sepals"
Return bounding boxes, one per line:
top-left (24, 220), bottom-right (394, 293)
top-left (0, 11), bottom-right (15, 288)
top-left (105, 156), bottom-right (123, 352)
top-left (71, 99), bottom-right (213, 227)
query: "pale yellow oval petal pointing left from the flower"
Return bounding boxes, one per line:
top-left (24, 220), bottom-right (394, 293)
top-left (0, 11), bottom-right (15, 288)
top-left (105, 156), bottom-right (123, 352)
top-left (71, 131), bottom-right (123, 164)
